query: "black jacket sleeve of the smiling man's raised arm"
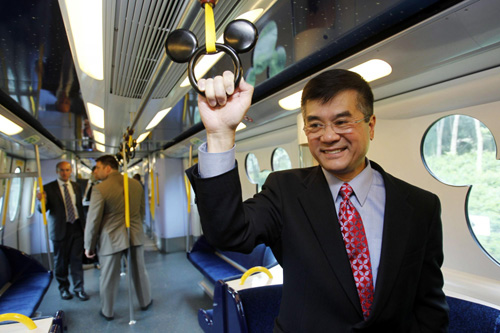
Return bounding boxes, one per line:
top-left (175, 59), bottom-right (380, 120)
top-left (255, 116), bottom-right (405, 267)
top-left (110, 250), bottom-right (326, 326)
top-left (186, 165), bottom-right (282, 253)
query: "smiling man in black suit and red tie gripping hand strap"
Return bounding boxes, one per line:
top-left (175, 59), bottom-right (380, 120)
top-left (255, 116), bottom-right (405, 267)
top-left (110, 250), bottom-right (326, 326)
top-left (187, 70), bottom-right (448, 332)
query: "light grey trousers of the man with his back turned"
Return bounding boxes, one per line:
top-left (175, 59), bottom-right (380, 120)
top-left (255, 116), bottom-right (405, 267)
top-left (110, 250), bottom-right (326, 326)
top-left (99, 245), bottom-right (151, 317)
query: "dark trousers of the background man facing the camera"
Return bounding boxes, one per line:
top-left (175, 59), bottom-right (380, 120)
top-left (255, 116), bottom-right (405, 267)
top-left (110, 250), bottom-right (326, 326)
top-left (52, 220), bottom-right (83, 292)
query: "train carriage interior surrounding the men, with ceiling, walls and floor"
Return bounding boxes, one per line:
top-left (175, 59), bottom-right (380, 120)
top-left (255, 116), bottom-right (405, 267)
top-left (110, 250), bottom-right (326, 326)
top-left (0, 0), bottom-right (500, 332)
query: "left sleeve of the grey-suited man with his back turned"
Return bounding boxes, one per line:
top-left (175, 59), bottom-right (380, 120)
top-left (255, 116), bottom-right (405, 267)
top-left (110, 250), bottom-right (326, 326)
top-left (84, 186), bottom-right (104, 252)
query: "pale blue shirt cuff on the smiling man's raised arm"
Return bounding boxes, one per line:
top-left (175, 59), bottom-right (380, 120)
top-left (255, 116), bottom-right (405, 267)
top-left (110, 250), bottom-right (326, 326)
top-left (198, 142), bottom-right (236, 178)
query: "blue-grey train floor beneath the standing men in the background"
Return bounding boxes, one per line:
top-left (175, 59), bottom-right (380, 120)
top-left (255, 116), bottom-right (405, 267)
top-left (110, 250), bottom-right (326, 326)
top-left (38, 240), bottom-right (212, 333)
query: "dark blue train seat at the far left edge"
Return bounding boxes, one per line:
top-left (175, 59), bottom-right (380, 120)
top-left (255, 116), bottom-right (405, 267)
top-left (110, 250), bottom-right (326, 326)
top-left (0, 245), bottom-right (52, 317)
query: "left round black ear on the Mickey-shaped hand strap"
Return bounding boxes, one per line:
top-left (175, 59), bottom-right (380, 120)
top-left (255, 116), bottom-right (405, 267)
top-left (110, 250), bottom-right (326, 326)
top-left (165, 29), bottom-right (198, 63)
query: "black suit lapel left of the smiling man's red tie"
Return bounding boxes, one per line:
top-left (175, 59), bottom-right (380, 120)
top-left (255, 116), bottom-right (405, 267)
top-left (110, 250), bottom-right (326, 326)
top-left (299, 167), bottom-right (362, 315)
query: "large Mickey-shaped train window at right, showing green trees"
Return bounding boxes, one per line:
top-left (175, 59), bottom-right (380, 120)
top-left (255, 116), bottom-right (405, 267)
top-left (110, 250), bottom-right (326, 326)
top-left (422, 115), bottom-right (500, 264)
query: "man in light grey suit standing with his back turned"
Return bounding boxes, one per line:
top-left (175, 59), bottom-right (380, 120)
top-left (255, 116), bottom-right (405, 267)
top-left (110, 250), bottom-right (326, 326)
top-left (84, 155), bottom-right (153, 321)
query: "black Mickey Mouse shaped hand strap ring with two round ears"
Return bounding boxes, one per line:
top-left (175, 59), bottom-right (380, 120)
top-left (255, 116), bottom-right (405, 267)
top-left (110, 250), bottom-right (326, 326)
top-left (165, 20), bottom-right (258, 96)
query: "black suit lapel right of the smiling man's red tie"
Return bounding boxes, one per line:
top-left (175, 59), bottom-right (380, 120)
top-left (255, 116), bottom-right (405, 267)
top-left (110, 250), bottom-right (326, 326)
top-left (370, 162), bottom-right (413, 317)
